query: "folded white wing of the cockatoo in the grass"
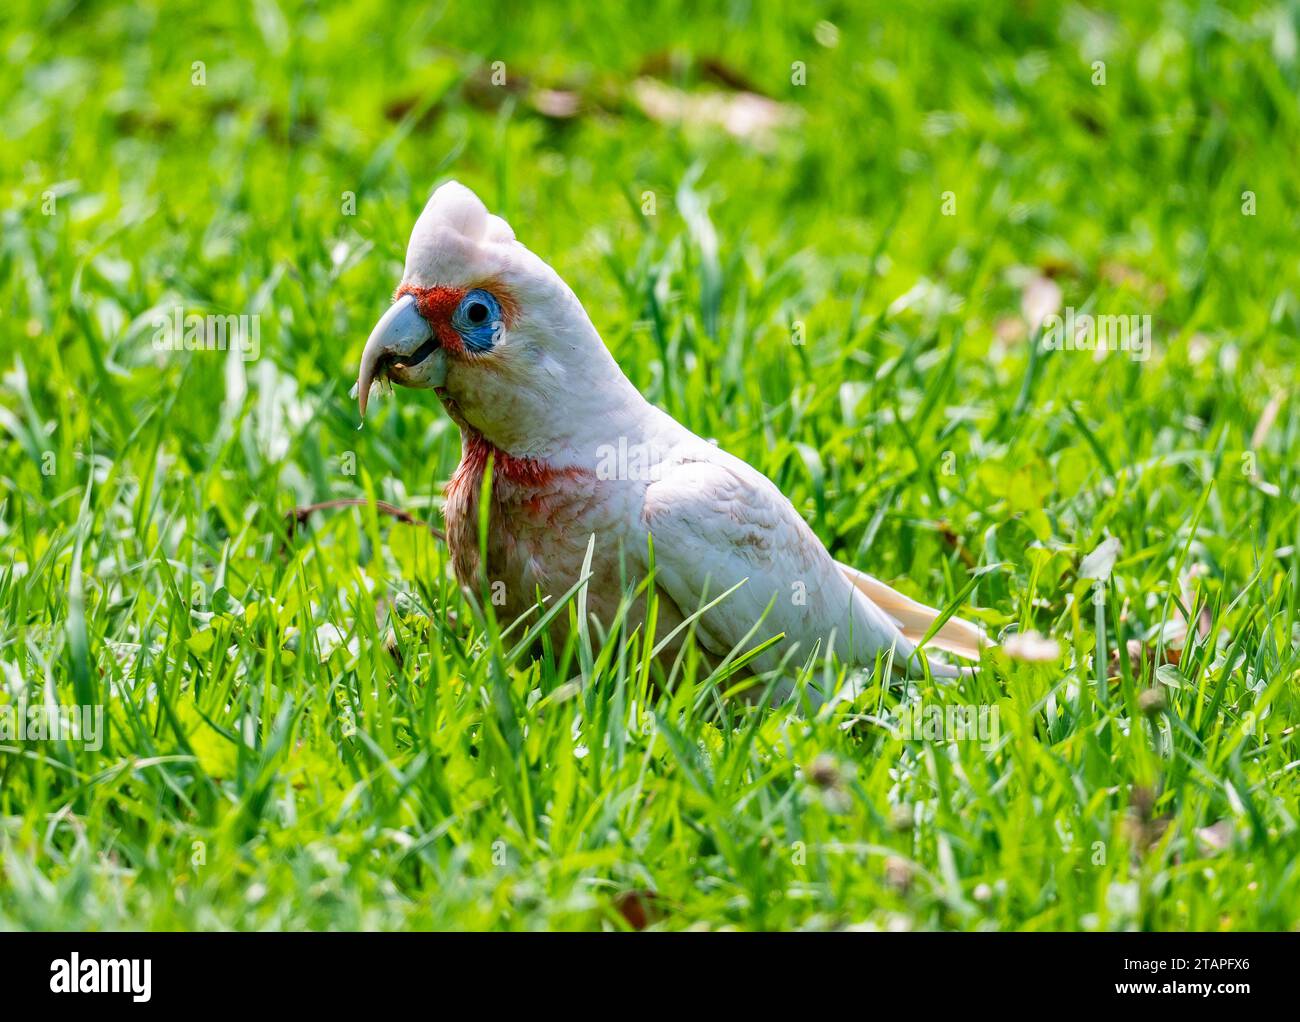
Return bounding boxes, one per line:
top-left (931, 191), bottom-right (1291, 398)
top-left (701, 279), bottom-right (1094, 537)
top-left (642, 449), bottom-right (957, 676)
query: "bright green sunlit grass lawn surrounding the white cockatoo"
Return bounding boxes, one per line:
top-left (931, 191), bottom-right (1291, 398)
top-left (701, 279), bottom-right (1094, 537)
top-left (0, 0), bottom-right (1300, 930)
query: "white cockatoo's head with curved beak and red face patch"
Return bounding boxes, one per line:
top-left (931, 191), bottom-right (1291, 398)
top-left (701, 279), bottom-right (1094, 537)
top-left (356, 181), bottom-right (634, 455)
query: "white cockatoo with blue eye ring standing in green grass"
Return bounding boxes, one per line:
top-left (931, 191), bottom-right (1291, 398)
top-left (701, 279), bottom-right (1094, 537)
top-left (358, 182), bottom-right (984, 696)
